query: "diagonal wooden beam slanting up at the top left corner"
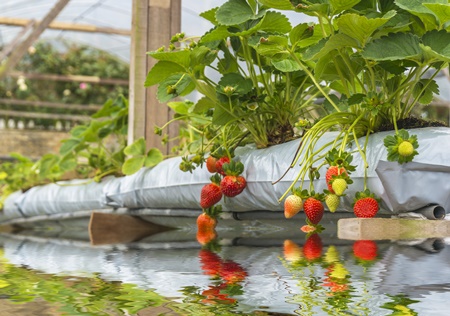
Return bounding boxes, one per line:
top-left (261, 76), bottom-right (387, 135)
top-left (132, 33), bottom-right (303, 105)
top-left (0, 0), bottom-right (70, 79)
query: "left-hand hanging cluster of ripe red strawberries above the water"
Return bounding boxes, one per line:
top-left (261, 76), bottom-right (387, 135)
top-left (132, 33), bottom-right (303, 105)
top-left (197, 156), bottom-right (247, 245)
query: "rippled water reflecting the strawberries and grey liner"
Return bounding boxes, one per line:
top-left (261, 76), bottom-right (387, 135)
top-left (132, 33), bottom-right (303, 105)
top-left (0, 217), bottom-right (450, 316)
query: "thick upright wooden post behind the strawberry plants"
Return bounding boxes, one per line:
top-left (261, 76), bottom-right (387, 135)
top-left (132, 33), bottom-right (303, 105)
top-left (128, 0), bottom-right (181, 153)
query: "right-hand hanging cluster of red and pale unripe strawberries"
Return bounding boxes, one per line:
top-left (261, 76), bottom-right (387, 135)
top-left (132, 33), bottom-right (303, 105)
top-left (284, 149), bottom-right (379, 227)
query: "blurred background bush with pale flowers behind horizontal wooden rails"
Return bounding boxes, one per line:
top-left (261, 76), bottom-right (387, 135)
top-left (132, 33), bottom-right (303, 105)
top-left (0, 40), bottom-right (129, 129)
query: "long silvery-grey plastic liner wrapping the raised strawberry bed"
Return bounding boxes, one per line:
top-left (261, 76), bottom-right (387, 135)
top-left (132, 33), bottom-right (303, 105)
top-left (0, 127), bottom-right (450, 221)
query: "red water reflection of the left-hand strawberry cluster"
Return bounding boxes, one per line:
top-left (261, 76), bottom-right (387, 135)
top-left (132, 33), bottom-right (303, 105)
top-left (198, 249), bottom-right (247, 304)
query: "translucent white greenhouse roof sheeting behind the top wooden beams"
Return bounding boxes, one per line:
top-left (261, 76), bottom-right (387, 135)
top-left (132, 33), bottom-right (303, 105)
top-left (0, 0), bottom-right (225, 61)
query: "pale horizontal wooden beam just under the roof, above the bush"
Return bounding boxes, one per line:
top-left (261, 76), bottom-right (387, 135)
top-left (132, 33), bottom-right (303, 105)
top-left (0, 17), bottom-right (131, 36)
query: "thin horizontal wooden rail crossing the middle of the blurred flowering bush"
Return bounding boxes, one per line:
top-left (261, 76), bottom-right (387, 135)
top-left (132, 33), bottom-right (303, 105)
top-left (8, 71), bottom-right (129, 86)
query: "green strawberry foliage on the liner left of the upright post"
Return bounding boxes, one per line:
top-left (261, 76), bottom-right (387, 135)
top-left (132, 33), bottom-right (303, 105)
top-left (0, 96), bottom-right (163, 204)
